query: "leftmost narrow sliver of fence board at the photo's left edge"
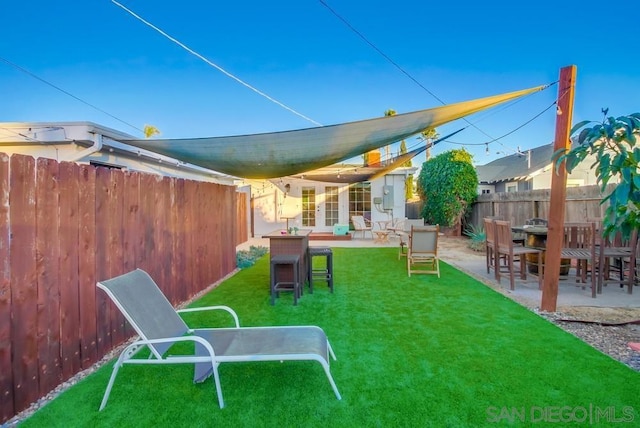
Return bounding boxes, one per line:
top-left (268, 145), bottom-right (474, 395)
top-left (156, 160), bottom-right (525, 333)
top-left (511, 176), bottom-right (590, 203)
top-left (0, 153), bottom-right (16, 423)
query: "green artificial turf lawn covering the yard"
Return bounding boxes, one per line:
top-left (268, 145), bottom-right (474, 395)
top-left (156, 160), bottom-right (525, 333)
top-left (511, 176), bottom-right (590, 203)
top-left (23, 248), bottom-right (640, 427)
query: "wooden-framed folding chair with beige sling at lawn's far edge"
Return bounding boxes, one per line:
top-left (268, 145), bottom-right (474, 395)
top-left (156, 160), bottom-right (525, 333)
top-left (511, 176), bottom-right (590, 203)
top-left (407, 225), bottom-right (440, 278)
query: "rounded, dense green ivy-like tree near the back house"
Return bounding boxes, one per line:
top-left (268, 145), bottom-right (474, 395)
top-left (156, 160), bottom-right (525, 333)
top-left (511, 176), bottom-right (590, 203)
top-left (418, 149), bottom-right (478, 227)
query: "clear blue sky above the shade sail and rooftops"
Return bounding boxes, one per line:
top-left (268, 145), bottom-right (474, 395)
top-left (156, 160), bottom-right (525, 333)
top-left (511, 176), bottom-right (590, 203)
top-left (0, 0), bottom-right (640, 164)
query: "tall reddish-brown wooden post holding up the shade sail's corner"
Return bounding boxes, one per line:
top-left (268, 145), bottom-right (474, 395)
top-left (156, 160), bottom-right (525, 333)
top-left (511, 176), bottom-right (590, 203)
top-left (540, 65), bottom-right (577, 312)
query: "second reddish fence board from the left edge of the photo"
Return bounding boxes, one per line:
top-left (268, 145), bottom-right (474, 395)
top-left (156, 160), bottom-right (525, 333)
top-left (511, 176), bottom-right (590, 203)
top-left (9, 155), bottom-right (38, 412)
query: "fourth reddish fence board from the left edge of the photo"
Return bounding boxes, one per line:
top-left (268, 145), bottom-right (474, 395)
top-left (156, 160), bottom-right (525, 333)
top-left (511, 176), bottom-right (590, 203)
top-left (59, 162), bottom-right (82, 380)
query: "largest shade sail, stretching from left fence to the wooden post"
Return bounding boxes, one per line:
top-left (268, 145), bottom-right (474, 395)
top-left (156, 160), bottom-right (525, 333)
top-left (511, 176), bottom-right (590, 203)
top-left (121, 86), bottom-right (546, 179)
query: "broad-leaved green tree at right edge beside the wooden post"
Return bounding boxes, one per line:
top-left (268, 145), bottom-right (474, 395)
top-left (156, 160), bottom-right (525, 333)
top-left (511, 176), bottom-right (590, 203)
top-left (554, 109), bottom-right (640, 238)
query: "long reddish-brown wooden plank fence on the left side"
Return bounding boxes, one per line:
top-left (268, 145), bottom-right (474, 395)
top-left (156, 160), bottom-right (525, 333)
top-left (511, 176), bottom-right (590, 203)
top-left (0, 154), bottom-right (247, 423)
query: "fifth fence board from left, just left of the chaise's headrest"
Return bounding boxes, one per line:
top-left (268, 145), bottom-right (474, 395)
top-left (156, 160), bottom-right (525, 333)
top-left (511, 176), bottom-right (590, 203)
top-left (78, 165), bottom-right (99, 369)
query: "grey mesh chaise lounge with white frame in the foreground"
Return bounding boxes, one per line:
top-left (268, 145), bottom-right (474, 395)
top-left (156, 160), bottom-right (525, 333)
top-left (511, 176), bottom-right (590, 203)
top-left (97, 269), bottom-right (341, 410)
